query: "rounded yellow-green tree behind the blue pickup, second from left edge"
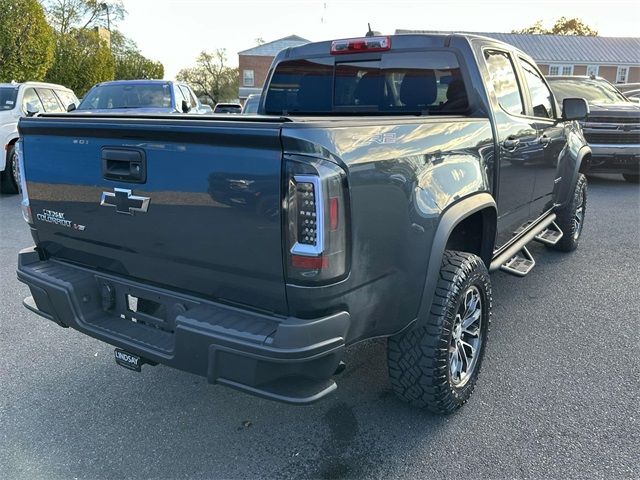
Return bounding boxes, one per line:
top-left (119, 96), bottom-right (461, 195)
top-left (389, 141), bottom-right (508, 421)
top-left (46, 29), bottom-right (115, 97)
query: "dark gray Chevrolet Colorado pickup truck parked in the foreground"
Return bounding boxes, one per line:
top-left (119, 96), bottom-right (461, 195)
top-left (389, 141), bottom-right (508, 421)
top-left (18, 35), bottom-right (590, 413)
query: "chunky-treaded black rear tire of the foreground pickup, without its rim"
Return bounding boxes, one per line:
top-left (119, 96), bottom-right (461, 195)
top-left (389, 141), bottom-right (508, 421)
top-left (387, 250), bottom-right (492, 415)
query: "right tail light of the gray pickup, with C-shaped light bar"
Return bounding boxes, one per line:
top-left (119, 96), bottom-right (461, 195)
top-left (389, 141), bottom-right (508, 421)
top-left (286, 159), bottom-right (349, 283)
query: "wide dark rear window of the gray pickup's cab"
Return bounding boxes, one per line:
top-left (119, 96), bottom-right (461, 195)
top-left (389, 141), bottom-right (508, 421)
top-left (265, 51), bottom-right (469, 115)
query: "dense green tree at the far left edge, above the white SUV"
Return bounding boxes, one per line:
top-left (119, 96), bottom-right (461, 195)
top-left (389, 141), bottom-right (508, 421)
top-left (0, 0), bottom-right (54, 82)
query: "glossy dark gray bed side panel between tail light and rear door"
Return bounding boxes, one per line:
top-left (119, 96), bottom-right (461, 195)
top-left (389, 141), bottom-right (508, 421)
top-left (282, 117), bottom-right (494, 342)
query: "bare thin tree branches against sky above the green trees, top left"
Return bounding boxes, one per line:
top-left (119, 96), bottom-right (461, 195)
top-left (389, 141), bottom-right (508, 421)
top-left (41, 0), bottom-right (127, 33)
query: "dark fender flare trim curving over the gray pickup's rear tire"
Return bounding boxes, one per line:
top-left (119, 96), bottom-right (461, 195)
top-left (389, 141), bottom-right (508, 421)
top-left (415, 192), bottom-right (497, 327)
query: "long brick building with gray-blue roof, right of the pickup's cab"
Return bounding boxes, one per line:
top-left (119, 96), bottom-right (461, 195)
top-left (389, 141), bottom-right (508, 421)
top-left (396, 30), bottom-right (640, 83)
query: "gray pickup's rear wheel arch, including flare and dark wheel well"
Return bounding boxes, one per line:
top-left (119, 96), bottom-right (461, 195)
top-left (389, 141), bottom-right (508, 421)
top-left (416, 192), bottom-right (498, 326)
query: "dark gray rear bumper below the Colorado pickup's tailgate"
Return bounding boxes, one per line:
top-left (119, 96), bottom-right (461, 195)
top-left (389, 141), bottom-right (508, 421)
top-left (17, 248), bottom-right (350, 404)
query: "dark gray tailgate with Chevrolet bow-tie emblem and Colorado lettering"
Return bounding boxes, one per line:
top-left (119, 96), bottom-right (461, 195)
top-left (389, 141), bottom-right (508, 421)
top-left (20, 115), bottom-right (287, 314)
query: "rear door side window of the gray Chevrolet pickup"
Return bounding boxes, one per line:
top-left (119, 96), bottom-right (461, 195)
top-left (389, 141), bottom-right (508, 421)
top-left (484, 50), bottom-right (524, 115)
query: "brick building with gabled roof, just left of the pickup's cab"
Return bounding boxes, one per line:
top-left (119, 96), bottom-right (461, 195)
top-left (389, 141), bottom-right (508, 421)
top-left (238, 35), bottom-right (309, 100)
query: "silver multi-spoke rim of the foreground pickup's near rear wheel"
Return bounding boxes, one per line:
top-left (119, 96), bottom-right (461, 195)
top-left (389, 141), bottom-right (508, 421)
top-left (449, 285), bottom-right (483, 387)
